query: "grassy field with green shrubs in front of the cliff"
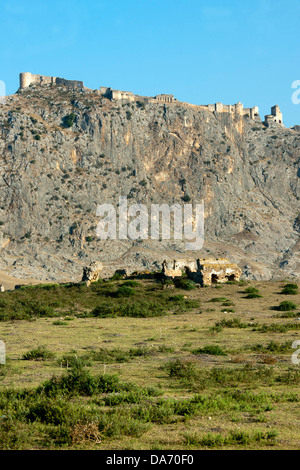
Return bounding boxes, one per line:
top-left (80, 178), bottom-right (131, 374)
top-left (0, 276), bottom-right (300, 450)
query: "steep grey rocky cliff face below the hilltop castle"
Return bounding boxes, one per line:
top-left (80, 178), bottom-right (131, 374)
top-left (0, 86), bottom-right (300, 280)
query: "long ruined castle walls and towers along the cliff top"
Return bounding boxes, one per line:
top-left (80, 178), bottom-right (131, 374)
top-left (19, 72), bottom-right (283, 127)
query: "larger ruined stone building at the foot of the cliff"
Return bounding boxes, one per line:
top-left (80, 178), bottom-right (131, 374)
top-left (162, 259), bottom-right (242, 286)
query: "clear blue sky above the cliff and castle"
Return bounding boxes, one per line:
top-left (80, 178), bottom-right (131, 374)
top-left (0, 0), bottom-right (300, 127)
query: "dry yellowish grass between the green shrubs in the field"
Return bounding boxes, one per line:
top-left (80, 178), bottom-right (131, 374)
top-left (0, 280), bottom-right (300, 449)
